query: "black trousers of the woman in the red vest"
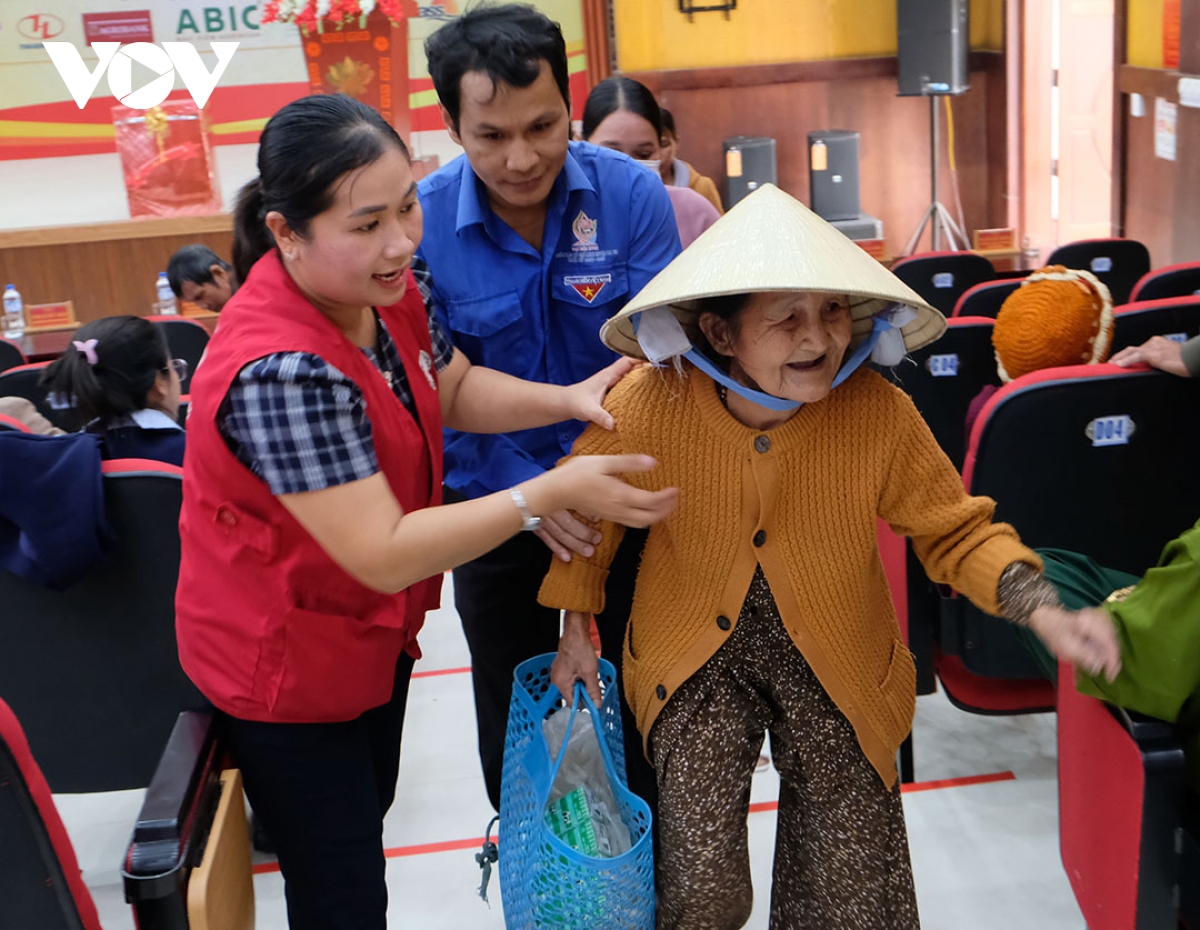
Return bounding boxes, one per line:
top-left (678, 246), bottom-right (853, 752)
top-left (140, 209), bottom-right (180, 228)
top-left (223, 655), bottom-right (413, 930)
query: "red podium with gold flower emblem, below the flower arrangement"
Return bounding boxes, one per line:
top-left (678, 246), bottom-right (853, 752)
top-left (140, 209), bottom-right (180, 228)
top-left (304, 10), bottom-right (412, 144)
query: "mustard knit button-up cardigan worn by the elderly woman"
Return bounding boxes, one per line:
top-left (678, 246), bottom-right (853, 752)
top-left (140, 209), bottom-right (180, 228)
top-left (539, 366), bottom-right (1042, 786)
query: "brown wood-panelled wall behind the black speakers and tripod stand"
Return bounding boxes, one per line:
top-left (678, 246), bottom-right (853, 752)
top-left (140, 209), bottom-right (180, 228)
top-left (630, 53), bottom-right (1008, 254)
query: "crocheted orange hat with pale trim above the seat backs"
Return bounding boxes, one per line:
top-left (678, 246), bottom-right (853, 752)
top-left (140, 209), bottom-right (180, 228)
top-left (991, 265), bottom-right (1112, 383)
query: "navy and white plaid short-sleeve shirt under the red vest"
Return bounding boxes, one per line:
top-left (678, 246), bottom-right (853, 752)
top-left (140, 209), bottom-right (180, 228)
top-left (217, 259), bottom-right (454, 494)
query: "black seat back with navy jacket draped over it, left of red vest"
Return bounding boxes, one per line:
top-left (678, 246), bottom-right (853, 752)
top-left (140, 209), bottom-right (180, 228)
top-left (0, 460), bottom-right (203, 792)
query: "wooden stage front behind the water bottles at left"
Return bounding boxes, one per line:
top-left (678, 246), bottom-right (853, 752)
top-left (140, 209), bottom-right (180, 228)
top-left (0, 215), bottom-right (233, 323)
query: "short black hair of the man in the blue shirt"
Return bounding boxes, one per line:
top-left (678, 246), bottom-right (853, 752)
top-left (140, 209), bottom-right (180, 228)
top-left (425, 4), bottom-right (571, 132)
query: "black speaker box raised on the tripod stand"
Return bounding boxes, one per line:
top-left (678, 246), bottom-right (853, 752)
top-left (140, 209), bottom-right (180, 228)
top-left (896, 0), bottom-right (971, 97)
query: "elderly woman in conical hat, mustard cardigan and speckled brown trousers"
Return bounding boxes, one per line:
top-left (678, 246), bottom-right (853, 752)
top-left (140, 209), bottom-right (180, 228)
top-left (540, 186), bottom-right (1120, 930)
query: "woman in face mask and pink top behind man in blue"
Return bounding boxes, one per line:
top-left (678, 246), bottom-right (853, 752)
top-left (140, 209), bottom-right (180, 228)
top-left (583, 77), bottom-right (720, 248)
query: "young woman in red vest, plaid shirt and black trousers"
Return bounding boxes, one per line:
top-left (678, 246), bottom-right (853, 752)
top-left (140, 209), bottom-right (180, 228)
top-left (176, 96), bottom-right (676, 930)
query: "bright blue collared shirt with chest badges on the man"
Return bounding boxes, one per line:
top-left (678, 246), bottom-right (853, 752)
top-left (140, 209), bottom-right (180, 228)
top-left (418, 142), bottom-right (680, 497)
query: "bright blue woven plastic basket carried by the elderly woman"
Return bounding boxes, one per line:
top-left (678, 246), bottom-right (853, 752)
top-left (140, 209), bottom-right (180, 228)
top-left (499, 653), bottom-right (654, 930)
